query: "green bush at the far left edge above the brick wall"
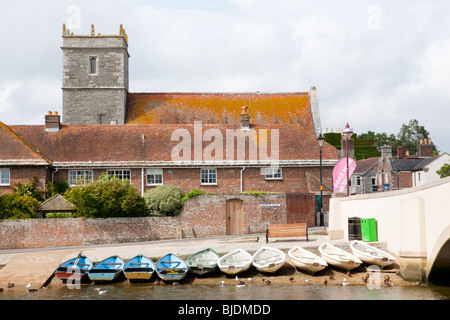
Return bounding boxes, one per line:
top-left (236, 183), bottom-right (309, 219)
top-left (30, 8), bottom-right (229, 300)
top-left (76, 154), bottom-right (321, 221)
top-left (0, 193), bottom-right (39, 219)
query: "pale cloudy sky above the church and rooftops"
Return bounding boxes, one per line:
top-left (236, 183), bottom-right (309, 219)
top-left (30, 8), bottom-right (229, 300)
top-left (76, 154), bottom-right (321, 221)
top-left (0, 0), bottom-right (450, 152)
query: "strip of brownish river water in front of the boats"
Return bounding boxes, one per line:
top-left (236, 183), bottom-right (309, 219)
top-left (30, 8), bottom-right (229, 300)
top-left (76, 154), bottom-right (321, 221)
top-left (0, 283), bottom-right (450, 300)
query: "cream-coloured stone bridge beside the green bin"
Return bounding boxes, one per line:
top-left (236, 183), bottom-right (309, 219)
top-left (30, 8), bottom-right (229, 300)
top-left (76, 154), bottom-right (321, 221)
top-left (328, 177), bottom-right (450, 285)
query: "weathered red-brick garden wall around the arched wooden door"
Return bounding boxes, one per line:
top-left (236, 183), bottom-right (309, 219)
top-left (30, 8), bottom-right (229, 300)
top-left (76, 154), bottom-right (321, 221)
top-left (0, 193), bottom-right (287, 249)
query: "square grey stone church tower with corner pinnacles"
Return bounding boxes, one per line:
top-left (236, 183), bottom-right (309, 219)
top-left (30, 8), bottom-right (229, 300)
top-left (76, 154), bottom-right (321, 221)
top-left (61, 25), bottom-right (130, 125)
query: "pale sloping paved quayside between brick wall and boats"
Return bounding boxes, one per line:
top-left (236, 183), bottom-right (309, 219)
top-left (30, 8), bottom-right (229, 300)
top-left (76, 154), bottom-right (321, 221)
top-left (0, 230), bottom-right (356, 289)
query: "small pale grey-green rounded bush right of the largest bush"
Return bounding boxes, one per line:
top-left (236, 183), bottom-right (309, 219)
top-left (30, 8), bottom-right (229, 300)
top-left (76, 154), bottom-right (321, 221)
top-left (144, 186), bottom-right (183, 216)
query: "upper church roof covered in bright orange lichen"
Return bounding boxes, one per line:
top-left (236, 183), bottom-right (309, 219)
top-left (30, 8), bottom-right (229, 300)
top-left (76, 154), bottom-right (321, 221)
top-left (126, 92), bottom-right (313, 132)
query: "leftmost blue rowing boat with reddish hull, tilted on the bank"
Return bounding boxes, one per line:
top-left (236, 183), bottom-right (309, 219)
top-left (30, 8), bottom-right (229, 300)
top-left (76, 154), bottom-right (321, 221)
top-left (55, 251), bottom-right (93, 282)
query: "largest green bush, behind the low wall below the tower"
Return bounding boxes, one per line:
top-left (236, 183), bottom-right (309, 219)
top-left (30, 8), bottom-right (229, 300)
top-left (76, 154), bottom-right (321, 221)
top-left (64, 175), bottom-right (148, 218)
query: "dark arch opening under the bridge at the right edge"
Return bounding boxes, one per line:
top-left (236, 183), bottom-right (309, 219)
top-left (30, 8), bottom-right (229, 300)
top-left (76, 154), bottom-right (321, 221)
top-left (426, 226), bottom-right (450, 286)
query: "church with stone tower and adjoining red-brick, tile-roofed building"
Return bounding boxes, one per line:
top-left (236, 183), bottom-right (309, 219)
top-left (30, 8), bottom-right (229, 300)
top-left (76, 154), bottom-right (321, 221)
top-left (0, 26), bottom-right (338, 229)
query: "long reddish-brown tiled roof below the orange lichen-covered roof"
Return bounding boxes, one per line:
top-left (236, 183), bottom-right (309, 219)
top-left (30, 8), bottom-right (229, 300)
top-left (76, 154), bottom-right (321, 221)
top-left (8, 124), bottom-right (337, 166)
